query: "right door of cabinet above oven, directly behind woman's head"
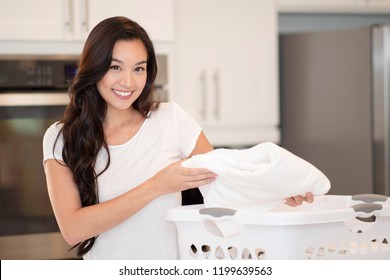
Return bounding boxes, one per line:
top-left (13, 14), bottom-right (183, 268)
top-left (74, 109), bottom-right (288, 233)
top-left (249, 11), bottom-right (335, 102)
top-left (87, 0), bottom-right (174, 41)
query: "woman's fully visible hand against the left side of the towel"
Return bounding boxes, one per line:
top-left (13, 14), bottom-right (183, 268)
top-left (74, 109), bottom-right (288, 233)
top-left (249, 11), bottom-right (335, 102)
top-left (151, 161), bottom-right (217, 195)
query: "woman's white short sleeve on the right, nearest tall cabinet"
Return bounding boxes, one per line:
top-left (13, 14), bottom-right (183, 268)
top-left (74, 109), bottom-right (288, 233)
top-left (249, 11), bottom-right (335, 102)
top-left (172, 102), bottom-right (202, 158)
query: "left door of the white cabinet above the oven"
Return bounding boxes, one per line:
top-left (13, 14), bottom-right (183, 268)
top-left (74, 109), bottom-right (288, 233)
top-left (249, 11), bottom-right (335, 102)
top-left (0, 0), bottom-right (72, 40)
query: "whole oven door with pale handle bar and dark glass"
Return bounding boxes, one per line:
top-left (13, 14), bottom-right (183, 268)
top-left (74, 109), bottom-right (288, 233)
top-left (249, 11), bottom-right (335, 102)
top-left (0, 92), bottom-right (75, 259)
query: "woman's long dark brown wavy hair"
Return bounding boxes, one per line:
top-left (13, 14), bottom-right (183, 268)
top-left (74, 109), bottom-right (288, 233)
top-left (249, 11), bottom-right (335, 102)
top-left (56, 17), bottom-right (159, 256)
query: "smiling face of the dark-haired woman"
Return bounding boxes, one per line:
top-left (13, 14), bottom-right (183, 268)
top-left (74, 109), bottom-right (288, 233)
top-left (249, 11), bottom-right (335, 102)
top-left (96, 39), bottom-right (148, 114)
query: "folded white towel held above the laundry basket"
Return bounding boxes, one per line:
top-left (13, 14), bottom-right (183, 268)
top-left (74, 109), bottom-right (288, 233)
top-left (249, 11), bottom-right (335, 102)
top-left (182, 142), bottom-right (330, 211)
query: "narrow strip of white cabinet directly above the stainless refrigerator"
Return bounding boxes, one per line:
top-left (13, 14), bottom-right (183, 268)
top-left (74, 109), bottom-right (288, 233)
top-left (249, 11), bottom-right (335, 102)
top-left (277, 0), bottom-right (390, 14)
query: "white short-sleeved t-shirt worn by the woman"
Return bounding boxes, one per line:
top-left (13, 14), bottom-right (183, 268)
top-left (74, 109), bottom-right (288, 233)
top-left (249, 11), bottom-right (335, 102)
top-left (43, 103), bottom-right (201, 260)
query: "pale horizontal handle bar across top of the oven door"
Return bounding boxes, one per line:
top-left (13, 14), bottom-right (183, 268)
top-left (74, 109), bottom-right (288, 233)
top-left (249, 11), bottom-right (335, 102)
top-left (0, 92), bottom-right (69, 107)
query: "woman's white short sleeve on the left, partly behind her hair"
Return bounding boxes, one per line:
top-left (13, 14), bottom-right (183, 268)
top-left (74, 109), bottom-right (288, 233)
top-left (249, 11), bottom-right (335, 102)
top-left (43, 122), bottom-right (63, 162)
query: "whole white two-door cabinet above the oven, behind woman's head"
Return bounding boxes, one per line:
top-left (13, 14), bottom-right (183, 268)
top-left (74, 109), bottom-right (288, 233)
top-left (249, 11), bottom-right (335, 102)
top-left (0, 0), bottom-right (173, 41)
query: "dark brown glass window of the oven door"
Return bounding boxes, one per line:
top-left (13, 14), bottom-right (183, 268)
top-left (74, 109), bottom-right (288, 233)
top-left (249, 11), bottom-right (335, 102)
top-left (0, 105), bottom-right (65, 236)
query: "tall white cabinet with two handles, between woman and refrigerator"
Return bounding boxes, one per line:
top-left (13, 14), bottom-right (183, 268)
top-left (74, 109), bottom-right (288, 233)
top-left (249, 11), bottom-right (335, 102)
top-left (172, 0), bottom-right (279, 146)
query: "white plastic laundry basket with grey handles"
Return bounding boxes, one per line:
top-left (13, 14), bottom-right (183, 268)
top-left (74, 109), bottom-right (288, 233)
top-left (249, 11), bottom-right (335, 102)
top-left (167, 194), bottom-right (390, 260)
